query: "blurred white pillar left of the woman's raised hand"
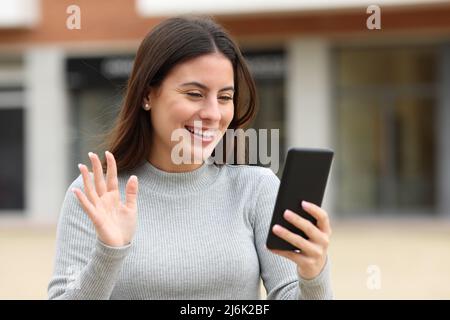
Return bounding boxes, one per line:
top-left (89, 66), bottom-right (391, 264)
top-left (25, 47), bottom-right (69, 223)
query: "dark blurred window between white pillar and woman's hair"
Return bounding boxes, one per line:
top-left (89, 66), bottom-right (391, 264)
top-left (66, 55), bottom-right (134, 181)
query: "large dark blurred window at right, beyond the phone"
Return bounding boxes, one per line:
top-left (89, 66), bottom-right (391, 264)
top-left (335, 47), bottom-right (437, 215)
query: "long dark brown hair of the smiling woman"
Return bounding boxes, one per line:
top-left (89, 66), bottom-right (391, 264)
top-left (102, 15), bottom-right (257, 173)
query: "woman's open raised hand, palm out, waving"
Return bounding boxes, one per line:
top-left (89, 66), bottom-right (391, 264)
top-left (72, 151), bottom-right (138, 247)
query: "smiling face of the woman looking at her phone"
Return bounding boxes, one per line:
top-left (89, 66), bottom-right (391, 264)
top-left (144, 53), bottom-right (234, 171)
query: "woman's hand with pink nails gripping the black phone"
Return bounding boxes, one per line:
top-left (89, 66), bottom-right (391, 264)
top-left (269, 201), bottom-right (331, 280)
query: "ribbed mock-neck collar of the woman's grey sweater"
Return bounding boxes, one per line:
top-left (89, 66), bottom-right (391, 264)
top-left (137, 160), bottom-right (220, 195)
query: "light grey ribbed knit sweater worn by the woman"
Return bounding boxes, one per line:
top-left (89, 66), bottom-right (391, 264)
top-left (48, 162), bottom-right (332, 300)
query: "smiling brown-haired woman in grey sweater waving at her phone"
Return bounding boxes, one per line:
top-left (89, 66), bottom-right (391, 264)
top-left (48, 16), bottom-right (332, 299)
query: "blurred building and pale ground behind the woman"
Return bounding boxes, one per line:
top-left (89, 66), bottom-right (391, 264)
top-left (0, 0), bottom-right (450, 299)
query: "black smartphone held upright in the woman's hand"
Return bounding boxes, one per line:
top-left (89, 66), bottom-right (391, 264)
top-left (266, 148), bottom-right (334, 250)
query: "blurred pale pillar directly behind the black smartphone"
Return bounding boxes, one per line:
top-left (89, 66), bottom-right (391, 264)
top-left (286, 38), bottom-right (335, 216)
